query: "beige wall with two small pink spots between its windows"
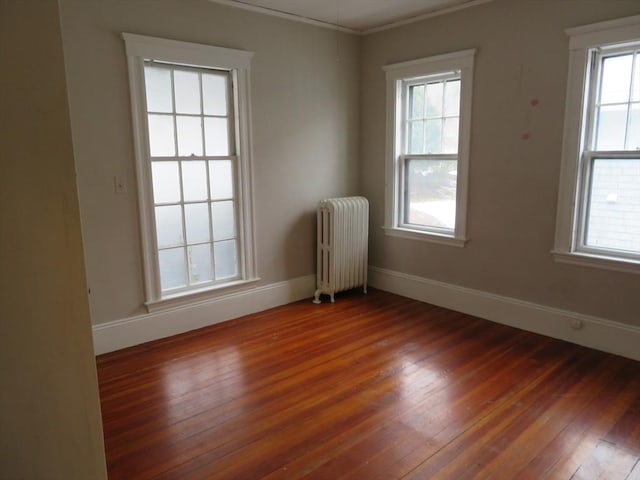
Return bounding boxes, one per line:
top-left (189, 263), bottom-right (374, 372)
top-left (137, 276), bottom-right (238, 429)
top-left (360, 0), bottom-right (640, 325)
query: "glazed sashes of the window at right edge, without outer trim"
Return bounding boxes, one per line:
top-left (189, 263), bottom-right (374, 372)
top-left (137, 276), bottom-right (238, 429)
top-left (575, 47), bottom-right (640, 259)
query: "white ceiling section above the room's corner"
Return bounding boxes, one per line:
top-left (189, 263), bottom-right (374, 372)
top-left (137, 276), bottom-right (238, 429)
top-left (211, 0), bottom-right (491, 33)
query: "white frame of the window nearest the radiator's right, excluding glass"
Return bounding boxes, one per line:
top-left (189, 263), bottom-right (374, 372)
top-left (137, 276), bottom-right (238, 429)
top-left (383, 49), bottom-right (476, 247)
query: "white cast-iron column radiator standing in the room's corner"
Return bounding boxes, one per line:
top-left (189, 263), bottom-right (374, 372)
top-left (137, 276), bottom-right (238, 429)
top-left (313, 197), bottom-right (369, 303)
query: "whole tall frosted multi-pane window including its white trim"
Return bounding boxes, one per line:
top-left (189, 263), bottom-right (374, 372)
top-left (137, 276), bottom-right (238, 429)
top-left (124, 34), bottom-right (255, 308)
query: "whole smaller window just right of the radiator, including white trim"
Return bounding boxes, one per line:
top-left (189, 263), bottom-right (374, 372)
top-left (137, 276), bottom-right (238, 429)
top-left (384, 50), bottom-right (475, 246)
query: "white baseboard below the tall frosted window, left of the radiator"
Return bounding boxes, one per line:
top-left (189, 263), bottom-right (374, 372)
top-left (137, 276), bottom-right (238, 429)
top-left (93, 275), bottom-right (316, 355)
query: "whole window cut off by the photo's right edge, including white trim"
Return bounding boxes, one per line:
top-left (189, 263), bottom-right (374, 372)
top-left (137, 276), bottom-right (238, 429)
top-left (554, 16), bottom-right (640, 273)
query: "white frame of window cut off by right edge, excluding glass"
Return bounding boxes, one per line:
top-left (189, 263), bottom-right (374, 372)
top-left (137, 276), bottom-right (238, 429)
top-left (551, 15), bottom-right (640, 273)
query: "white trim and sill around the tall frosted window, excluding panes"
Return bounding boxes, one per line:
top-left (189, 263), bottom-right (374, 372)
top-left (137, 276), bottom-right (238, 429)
top-left (122, 33), bottom-right (259, 312)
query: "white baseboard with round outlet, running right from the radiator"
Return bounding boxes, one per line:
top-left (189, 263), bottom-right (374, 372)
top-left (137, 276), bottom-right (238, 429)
top-left (369, 267), bottom-right (640, 360)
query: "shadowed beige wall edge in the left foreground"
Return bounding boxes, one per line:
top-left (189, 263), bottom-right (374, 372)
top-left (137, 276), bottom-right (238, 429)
top-left (0, 0), bottom-right (106, 480)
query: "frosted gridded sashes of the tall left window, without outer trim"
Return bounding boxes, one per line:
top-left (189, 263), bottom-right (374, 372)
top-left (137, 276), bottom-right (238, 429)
top-left (144, 60), bottom-right (240, 295)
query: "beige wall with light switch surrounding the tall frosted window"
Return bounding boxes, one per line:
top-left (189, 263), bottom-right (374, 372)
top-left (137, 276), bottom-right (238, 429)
top-left (60, 0), bottom-right (359, 324)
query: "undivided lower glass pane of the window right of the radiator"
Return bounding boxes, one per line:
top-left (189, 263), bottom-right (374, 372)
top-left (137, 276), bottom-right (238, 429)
top-left (404, 159), bottom-right (458, 230)
